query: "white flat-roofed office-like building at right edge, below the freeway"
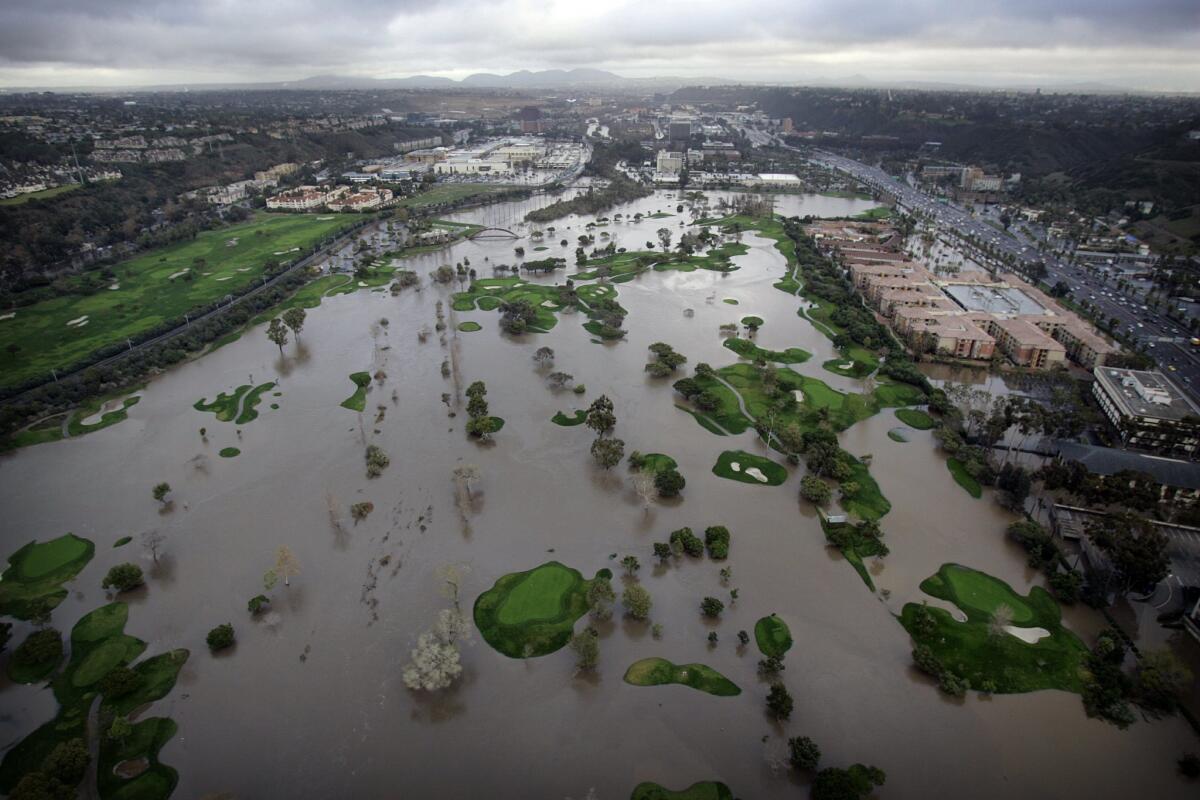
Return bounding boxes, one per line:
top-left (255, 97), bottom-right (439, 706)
top-left (1092, 367), bottom-right (1200, 456)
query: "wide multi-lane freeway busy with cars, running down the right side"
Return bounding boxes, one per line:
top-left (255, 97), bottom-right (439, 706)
top-left (782, 145), bottom-right (1200, 398)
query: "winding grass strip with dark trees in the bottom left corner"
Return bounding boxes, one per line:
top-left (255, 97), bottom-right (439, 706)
top-left (0, 603), bottom-right (188, 800)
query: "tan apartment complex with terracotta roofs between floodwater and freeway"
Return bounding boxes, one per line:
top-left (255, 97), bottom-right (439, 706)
top-left (808, 221), bottom-right (1116, 369)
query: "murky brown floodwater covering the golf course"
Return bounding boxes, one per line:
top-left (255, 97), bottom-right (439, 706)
top-left (0, 193), bottom-right (1195, 800)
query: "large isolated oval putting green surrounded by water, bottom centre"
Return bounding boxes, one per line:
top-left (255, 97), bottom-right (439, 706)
top-left (474, 561), bottom-right (612, 658)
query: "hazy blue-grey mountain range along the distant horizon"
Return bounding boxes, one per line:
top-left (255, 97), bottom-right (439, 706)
top-left (0, 67), bottom-right (1152, 94)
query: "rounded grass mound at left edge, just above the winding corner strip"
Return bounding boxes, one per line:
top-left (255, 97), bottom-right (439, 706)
top-left (0, 534), bottom-right (96, 620)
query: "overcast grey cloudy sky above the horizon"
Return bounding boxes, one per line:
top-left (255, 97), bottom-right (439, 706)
top-left (0, 0), bottom-right (1200, 91)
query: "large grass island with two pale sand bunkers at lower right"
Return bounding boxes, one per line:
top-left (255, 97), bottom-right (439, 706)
top-left (900, 564), bottom-right (1087, 693)
